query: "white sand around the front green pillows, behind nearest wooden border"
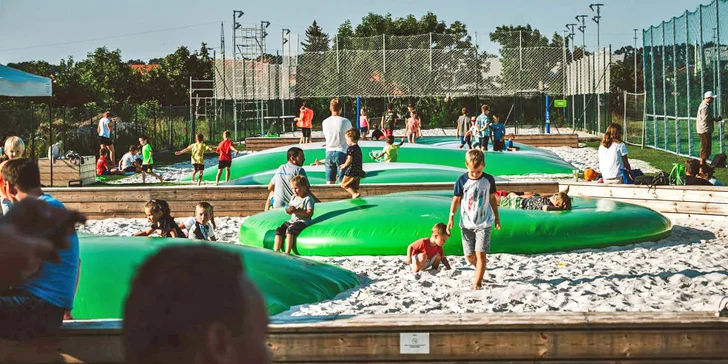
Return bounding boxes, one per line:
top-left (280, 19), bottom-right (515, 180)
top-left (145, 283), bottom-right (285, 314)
top-left (81, 217), bottom-right (728, 316)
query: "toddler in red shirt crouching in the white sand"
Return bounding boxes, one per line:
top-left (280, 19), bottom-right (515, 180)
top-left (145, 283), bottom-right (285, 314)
top-left (405, 222), bottom-right (450, 273)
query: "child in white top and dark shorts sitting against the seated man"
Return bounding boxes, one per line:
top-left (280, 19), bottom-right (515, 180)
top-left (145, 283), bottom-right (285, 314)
top-left (273, 175), bottom-right (314, 254)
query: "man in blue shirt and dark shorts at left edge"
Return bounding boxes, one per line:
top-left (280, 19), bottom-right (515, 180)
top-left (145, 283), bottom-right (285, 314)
top-left (0, 158), bottom-right (79, 340)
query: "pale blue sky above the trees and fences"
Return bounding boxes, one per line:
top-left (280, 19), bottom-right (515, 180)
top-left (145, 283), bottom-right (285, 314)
top-left (0, 0), bottom-right (710, 64)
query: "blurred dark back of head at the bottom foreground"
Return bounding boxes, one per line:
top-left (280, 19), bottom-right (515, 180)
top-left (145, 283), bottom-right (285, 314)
top-left (122, 244), bottom-right (270, 364)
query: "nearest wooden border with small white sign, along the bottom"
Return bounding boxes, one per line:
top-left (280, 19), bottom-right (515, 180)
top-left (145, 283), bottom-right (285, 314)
top-left (0, 312), bottom-right (728, 363)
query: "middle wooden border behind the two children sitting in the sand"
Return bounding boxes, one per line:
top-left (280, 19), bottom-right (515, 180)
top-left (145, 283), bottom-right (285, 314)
top-left (44, 182), bottom-right (558, 219)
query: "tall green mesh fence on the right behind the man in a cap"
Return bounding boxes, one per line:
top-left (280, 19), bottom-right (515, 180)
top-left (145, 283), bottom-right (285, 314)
top-left (642, 0), bottom-right (728, 157)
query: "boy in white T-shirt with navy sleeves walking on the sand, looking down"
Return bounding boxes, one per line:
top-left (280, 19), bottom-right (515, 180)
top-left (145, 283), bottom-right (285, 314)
top-left (447, 149), bottom-right (500, 290)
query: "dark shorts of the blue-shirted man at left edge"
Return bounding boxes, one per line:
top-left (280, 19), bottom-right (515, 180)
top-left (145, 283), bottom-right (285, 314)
top-left (0, 291), bottom-right (66, 341)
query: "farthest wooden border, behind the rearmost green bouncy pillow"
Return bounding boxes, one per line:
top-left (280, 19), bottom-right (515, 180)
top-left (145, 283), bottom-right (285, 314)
top-left (245, 134), bottom-right (579, 152)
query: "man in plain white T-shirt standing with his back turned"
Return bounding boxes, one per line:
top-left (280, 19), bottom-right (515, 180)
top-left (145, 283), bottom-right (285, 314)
top-left (317, 98), bottom-right (352, 185)
